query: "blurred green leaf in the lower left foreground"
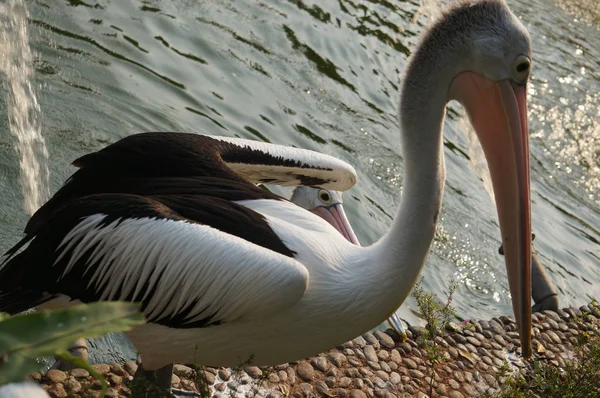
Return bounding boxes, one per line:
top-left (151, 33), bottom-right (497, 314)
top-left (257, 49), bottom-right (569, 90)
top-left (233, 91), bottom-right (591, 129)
top-left (0, 302), bottom-right (145, 385)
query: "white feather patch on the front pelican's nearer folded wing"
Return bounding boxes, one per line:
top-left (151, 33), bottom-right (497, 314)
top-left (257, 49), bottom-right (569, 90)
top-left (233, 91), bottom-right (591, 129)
top-left (55, 214), bottom-right (309, 322)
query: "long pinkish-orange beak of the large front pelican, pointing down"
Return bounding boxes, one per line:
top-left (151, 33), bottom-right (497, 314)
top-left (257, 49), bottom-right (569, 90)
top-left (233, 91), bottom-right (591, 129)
top-left (450, 72), bottom-right (532, 358)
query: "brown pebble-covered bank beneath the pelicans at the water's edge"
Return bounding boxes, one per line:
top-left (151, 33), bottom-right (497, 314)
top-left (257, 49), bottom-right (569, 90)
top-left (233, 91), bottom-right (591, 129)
top-left (30, 302), bottom-right (600, 398)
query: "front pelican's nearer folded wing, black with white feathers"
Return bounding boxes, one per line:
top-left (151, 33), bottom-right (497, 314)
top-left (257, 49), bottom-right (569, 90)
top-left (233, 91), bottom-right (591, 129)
top-left (0, 194), bottom-right (308, 328)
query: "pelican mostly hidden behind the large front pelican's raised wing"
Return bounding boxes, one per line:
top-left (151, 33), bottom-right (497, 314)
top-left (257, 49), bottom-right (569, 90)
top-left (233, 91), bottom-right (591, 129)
top-left (290, 186), bottom-right (408, 341)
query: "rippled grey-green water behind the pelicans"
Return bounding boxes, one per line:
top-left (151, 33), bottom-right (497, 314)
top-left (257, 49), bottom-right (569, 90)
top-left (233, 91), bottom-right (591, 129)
top-left (0, 0), bottom-right (600, 354)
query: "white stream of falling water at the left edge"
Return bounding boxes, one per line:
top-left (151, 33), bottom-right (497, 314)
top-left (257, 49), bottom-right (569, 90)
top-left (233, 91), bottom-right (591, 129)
top-left (0, 0), bottom-right (50, 214)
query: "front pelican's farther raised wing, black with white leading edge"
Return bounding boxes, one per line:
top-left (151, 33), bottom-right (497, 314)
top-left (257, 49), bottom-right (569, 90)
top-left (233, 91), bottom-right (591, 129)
top-left (25, 132), bottom-right (357, 233)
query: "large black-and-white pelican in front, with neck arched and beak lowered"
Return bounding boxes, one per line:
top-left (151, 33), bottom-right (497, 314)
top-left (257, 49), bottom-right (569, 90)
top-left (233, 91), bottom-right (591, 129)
top-left (0, 0), bottom-right (531, 396)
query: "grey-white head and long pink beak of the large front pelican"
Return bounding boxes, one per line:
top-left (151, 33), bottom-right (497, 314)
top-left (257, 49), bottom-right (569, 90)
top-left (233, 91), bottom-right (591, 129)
top-left (402, 0), bottom-right (532, 357)
